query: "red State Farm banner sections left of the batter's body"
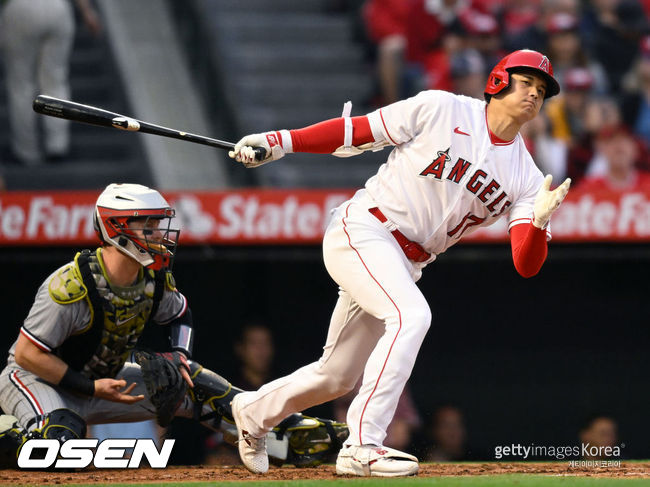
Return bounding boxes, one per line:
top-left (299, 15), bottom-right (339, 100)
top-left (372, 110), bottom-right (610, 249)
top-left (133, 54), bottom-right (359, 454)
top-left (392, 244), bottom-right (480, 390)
top-left (0, 190), bottom-right (354, 246)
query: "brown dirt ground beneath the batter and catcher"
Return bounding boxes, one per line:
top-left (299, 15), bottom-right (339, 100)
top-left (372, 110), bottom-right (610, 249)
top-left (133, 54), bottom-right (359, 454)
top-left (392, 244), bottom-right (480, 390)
top-left (0, 462), bottom-right (650, 485)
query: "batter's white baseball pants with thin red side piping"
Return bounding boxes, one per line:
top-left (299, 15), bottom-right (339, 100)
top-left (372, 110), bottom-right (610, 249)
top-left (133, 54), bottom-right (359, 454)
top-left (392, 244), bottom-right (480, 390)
top-left (232, 190), bottom-right (431, 445)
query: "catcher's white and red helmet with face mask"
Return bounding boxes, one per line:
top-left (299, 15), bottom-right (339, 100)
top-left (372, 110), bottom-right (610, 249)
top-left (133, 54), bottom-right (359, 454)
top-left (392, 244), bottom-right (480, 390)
top-left (94, 184), bottom-right (180, 270)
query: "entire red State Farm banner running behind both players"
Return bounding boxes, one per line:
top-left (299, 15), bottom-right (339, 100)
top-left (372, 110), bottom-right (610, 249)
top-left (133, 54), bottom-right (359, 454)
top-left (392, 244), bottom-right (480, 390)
top-left (0, 189), bottom-right (650, 246)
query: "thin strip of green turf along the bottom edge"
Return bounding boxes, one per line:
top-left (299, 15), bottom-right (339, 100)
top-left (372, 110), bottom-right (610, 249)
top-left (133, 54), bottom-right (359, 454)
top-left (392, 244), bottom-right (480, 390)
top-left (24, 474), bottom-right (650, 487)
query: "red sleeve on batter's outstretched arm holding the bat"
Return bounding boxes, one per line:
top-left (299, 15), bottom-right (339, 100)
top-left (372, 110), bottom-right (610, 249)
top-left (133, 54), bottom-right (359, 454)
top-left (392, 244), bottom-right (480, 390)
top-left (290, 115), bottom-right (375, 154)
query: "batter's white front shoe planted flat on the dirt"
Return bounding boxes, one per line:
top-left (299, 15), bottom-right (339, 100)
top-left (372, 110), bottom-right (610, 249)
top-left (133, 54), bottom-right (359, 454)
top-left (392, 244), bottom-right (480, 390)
top-left (336, 445), bottom-right (420, 477)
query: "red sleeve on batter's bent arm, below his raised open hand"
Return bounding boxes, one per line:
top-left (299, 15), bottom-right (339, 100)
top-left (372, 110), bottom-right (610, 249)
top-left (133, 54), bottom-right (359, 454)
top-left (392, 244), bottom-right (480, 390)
top-left (510, 223), bottom-right (548, 277)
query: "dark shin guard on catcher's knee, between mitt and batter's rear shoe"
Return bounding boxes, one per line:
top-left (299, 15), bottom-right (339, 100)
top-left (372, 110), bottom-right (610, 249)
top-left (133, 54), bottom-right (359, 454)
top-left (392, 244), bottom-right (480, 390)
top-left (189, 361), bottom-right (242, 430)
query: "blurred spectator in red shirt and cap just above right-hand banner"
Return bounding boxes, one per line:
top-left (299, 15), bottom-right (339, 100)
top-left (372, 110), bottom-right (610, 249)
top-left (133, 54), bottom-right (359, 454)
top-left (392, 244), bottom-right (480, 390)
top-left (579, 124), bottom-right (650, 191)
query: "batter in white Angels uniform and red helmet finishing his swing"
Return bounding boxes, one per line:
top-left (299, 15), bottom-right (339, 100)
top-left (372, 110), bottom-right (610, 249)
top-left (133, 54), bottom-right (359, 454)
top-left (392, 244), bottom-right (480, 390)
top-left (230, 50), bottom-right (570, 476)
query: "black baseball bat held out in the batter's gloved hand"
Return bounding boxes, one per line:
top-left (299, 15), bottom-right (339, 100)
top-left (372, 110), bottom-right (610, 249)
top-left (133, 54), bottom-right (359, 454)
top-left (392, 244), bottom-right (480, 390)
top-left (33, 95), bottom-right (266, 161)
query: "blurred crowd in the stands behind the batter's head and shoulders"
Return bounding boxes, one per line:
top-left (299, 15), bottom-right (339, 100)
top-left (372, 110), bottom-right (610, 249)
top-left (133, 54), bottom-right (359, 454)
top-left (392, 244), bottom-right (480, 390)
top-left (361, 0), bottom-right (650, 191)
